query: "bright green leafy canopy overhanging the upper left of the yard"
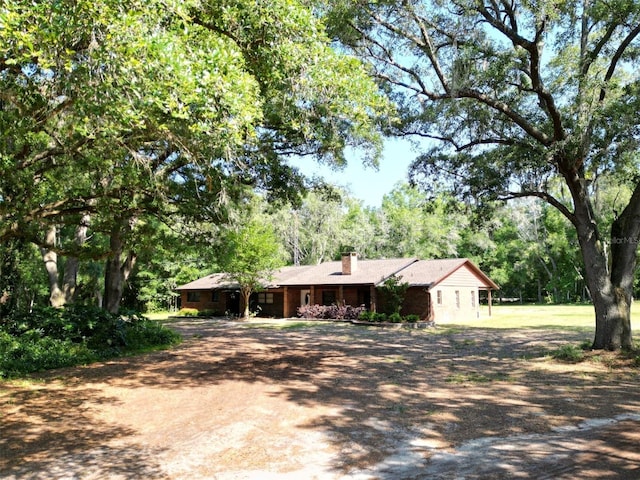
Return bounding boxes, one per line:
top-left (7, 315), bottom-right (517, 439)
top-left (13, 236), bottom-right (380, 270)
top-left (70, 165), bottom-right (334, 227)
top-left (0, 0), bottom-right (387, 244)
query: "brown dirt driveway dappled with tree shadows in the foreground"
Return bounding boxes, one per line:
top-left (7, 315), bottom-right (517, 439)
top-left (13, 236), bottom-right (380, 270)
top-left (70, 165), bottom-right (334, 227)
top-left (0, 320), bottom-right (640, 480)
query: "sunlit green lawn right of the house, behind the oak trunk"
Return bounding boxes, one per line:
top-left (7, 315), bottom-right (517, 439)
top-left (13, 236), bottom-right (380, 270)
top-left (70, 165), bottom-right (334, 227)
top-left (442, 304), bottom-right (640, 331)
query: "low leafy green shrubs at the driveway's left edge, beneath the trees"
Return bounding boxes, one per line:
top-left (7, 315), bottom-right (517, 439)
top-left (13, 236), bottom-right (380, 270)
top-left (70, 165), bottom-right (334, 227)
top-left (0, 306), bottom-right (179, 377)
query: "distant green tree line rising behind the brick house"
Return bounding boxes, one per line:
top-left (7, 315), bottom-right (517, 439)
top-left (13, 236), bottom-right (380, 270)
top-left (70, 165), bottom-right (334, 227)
top-left (2, 183), bottom-right (637, 311)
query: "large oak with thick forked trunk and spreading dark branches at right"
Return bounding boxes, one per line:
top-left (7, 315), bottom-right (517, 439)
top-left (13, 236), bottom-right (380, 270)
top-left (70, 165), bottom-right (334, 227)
top-left (325, 0), bottom-right (640, 349)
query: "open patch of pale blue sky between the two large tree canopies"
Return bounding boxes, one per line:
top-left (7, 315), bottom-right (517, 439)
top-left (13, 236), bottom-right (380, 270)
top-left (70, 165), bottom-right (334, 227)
top-left (292, 139), bottom-right (417, 207)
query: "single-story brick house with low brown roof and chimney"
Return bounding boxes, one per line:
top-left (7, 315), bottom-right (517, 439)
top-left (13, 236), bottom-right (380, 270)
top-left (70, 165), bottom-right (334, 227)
top-left (177, 252), bottom-right (498, 322)
